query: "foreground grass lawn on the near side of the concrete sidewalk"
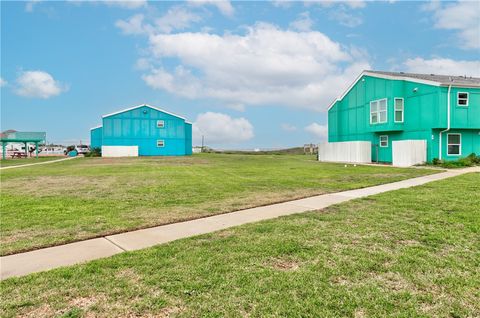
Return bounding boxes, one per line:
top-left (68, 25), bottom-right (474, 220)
top-left (0, 173), bottom-right (480, 317)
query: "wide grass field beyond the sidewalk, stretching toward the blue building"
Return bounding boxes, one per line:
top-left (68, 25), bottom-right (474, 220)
top-left (0, 154), bottom-right (433, 255)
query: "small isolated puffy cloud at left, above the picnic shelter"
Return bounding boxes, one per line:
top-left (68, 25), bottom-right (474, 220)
top-left (15, 71), bottom-right (67, 99)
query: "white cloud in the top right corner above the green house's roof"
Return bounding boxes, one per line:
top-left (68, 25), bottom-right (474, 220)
top-left (424, 1), bottom-right (480, 49)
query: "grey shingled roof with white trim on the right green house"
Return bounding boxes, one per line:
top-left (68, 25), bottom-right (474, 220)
top-left (328, 71), bottom-right (480, 110)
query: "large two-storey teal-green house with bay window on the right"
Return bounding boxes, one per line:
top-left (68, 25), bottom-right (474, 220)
top-left (328, 71), bottom-right (480, 163)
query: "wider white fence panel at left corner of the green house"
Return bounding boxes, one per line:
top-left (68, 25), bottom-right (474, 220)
top-left (318, 141), bottom-right (372, 163)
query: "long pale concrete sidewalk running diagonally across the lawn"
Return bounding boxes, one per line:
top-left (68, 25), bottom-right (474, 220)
top-left (0, 167), bottom-right (480, 279)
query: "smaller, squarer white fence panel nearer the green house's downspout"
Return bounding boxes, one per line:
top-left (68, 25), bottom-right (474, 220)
top-left (392, 140), bottom-right (427, 167)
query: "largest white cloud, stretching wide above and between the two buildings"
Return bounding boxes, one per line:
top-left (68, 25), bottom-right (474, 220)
top-left (143, 23), bottom-right (370, 110)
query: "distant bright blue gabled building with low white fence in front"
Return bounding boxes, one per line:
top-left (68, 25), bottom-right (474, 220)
top-left (90, 104), bottom-right (192, 157)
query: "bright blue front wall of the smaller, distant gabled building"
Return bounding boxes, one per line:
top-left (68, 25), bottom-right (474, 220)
top-left (102, 106), bottom-right (191, 156)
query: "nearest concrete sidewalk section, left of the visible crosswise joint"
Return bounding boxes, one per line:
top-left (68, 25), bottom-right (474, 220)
top-left (0, 238), bottom-right (123, 279)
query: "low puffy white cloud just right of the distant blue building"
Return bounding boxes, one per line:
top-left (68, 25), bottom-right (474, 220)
top-left (193, 112), bottom-right (254, 144)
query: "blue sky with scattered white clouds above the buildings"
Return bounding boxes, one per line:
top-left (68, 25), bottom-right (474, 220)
top-left (0, 0), bottom-right (480, 149)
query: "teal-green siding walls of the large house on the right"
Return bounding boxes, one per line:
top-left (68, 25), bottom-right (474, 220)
top-left (328, 76), bottom-right (480, 162)
